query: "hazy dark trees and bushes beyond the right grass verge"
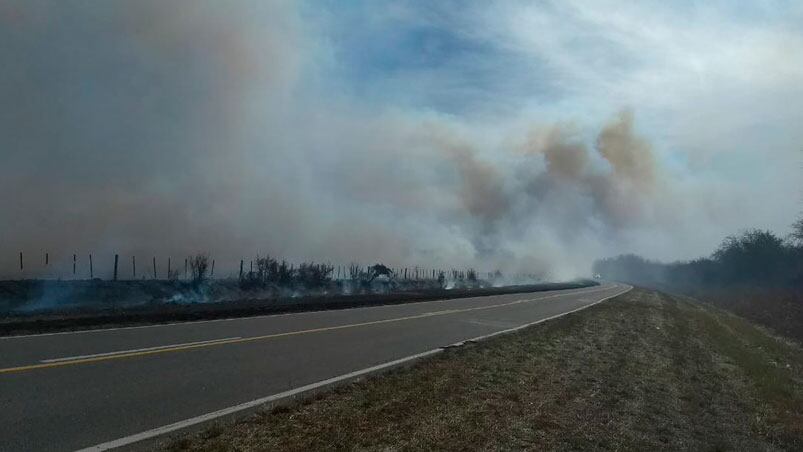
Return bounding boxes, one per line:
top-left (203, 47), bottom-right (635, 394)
top-left (594, 230), bottom-right (803, 340)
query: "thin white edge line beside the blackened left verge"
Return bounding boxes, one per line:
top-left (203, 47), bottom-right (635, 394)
top-left (0, 285), bottom-right (610, 341)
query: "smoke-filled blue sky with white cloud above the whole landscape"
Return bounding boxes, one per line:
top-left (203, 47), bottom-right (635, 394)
top-left (0, 0), bottom-right (803, 279)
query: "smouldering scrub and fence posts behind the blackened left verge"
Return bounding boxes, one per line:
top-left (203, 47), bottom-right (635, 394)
top-left (0, 253), bottom-right (508, 314)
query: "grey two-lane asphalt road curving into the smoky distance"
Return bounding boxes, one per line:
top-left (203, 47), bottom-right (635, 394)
top-left (0, 284), bottom-right (626, 451)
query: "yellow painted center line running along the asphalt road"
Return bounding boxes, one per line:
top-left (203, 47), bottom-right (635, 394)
top-left (0, 287), bottom-right (611, 374)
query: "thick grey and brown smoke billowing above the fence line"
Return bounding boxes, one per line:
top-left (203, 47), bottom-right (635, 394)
top-left (0, 0), bottom-right (803, 279)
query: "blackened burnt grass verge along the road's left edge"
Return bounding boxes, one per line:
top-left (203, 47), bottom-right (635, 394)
top-left (0, 280), bottom-right (598, 336)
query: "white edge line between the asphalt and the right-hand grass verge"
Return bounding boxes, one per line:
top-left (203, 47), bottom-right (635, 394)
top-left (77, 286), bottom-right (633, 452)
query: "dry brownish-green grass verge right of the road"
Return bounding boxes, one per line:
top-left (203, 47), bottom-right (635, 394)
top-left (165, 289), bottom-right (803, 451)
